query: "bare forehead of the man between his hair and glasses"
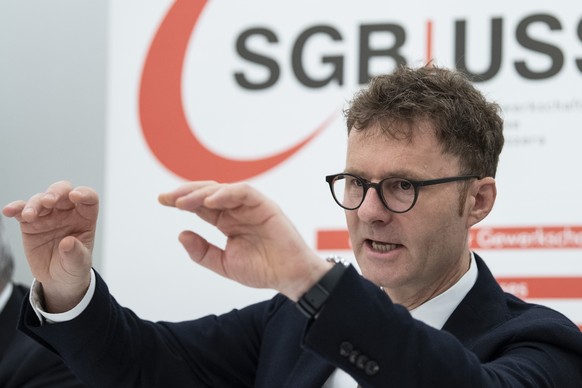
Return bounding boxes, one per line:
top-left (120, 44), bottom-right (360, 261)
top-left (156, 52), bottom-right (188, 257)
top-left (346, 121), bottom-right (459, 179)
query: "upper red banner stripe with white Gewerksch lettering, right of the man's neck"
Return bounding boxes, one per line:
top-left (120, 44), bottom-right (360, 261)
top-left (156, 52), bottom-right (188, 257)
top-left (470, 226), bottom-right (582, 249)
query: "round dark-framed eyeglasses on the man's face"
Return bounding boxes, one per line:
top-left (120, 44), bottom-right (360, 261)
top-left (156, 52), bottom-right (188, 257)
top-left (325, 173), bottom-right (481, 213)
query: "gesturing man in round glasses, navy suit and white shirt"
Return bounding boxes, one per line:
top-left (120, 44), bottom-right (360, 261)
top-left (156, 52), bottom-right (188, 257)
top-left (3, 67), bottom-right (582, 388)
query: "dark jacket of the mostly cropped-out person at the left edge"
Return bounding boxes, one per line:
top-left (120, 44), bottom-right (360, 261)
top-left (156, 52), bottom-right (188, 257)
top-left (0, 285), bottom-right (86, 388)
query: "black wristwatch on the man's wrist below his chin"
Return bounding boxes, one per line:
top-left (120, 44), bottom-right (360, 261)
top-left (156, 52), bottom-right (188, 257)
top-left (297, 256), bottom-right (347, 319)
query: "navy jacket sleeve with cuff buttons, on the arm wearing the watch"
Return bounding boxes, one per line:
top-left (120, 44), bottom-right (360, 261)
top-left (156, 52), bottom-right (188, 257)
top-left (304, 268), bottom-right (582, 387)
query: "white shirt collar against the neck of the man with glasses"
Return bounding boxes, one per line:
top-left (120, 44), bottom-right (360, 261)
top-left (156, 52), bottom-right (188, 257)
top-left (410, 252), bottom-right (479, 330)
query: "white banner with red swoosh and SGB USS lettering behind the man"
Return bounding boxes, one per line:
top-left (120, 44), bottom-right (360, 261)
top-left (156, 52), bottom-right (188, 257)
top-left (102, 0), bottom-right (582, 325)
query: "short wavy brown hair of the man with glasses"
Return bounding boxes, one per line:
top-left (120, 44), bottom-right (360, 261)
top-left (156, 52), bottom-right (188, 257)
top-left (344, 66), bottom-right (504, 177)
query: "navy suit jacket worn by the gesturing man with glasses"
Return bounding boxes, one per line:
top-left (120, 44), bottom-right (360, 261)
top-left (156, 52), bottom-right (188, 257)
top-left (21, 257), bottom-right (582, 388)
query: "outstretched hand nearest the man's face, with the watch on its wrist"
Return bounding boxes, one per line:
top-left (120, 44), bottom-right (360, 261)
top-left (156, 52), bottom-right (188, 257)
top-left (159, 182), bottom-right (330, 300)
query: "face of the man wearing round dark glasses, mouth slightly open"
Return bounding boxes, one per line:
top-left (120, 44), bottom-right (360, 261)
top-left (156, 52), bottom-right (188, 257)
top-left (345, 122), bottom-right (469, 308)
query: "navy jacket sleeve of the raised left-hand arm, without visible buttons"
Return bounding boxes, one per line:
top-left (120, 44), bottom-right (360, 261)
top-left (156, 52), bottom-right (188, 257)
top-left (19, 274), bottom-right (280, 388)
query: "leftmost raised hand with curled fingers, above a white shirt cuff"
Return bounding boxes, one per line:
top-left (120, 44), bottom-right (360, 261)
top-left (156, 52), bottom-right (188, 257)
top-left (2, 181), bottom-right (99, 313)
